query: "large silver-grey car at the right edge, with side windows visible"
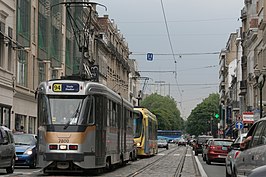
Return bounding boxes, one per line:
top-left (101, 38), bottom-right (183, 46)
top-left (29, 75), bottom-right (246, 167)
top-left (235, 118), bottom-right (266, 176)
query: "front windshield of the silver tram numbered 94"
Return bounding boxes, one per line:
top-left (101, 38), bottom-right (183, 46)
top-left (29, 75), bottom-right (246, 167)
top-left (38, 95), bottom-right (94, 128)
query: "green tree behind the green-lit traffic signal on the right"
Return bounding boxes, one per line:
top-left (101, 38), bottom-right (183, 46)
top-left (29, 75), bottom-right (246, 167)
top-left (186, 93), bottom-right (219, 136)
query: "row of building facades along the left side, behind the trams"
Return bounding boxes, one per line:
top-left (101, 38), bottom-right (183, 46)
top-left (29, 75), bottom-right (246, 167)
top-left (0, 0), bottom-right (139, 133)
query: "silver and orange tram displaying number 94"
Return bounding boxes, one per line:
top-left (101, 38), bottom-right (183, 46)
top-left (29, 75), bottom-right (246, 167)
top-left (37, 79), bottom-right (136, 173)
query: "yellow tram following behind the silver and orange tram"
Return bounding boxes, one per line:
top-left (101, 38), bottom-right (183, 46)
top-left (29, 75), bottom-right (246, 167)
top-left (134, 107), bottom-right (158, 157)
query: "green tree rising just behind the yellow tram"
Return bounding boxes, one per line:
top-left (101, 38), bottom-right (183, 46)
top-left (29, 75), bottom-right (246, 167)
top-left (141, 93), bottom-right (184, 130)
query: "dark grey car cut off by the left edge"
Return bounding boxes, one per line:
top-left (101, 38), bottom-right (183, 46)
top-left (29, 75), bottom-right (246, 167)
top-left (0, 126), bottom-right (16, 173)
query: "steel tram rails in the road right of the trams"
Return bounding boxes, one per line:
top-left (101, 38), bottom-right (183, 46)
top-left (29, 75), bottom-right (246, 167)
top-left (127, 147), bottom-right (188, 177)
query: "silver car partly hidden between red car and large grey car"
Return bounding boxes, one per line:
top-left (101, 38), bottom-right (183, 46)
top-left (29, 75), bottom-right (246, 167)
top-left (225, 133), bottom-right (247, 177)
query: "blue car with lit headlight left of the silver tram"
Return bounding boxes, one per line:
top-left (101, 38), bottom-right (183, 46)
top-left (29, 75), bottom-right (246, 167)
top-left (14, 133), bottom-right (37, 168)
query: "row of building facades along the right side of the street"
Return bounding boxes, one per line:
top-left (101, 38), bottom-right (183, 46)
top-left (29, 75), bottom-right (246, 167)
top-left (219, 0), bottom-right (266, 135)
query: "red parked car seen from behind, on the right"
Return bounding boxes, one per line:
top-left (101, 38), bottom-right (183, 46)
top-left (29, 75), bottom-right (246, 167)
top-left (206, 138), bottom-right (233, 165)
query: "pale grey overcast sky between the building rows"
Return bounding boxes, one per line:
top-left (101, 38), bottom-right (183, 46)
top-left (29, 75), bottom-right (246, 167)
top-left (94, 0), bottom-right (244, 119)
